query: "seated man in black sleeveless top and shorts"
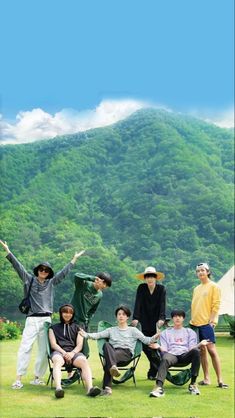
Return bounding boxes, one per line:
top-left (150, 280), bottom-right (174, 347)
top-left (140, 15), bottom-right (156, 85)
top-left (49, 304), bottom-right (101, 398)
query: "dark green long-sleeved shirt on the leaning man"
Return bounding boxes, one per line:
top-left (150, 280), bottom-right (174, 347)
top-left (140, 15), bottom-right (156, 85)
top-left (71, 273), bottom-right (103, 326)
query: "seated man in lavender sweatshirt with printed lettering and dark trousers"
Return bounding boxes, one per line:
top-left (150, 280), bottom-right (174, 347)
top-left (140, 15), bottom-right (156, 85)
top-left (149, 309), bottom-right (209, 398)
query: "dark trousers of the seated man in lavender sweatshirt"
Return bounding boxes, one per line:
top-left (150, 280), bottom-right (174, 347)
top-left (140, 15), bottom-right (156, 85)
top-left (157, 348), bottom-right (200, 383)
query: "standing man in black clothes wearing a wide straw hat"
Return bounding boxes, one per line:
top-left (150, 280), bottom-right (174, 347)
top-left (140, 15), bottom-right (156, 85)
top-left (132, 267), bottom-right (166, 380)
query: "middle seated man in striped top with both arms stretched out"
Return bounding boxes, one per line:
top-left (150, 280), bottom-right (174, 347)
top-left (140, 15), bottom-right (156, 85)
top-left (80, 305), bottom-right (159, 395)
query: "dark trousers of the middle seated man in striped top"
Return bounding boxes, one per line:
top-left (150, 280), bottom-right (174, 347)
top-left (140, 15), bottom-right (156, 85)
top-left (103, 343), bottom-right (132, 389)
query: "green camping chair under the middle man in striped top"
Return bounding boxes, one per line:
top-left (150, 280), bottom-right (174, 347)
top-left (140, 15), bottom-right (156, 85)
top-left (97, 321), bottom-right (142, 386)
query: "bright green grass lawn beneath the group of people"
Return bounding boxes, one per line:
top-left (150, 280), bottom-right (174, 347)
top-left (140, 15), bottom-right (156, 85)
top-left (0, 336), bottom-right (234, 418)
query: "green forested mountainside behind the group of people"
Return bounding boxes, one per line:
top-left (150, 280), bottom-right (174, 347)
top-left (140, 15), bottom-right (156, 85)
top-left (0, 109), bottom-right (234, 319)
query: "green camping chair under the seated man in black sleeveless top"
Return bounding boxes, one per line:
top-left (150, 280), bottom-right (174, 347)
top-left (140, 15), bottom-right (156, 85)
top-left (44, 322), bottom-right (89, 388)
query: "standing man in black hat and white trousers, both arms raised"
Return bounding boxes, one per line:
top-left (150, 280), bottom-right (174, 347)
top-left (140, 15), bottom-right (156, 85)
top-left (0, 240), bottom-right (84, 389)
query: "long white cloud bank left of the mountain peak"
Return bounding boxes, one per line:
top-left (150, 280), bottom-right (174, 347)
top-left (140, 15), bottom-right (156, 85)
top-left (0, 99), bottom-right (149, 144)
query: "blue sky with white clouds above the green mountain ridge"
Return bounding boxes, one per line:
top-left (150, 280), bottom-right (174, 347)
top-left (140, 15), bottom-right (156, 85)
top-left (0, 0), bottom-right (234, 144)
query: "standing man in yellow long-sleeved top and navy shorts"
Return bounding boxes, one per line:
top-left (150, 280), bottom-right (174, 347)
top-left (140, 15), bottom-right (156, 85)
top-left (190, 263), bottom-right (228, 389)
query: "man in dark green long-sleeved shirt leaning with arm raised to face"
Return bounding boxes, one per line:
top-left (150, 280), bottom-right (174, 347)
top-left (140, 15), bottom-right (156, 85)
top-left (71, 272), bottom-right (112, 331)
